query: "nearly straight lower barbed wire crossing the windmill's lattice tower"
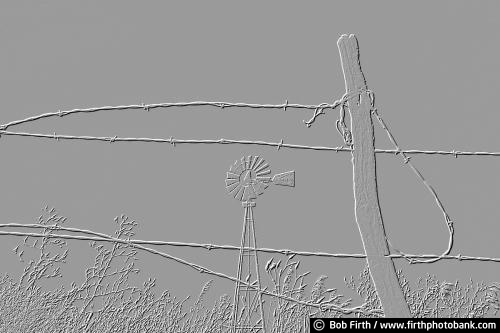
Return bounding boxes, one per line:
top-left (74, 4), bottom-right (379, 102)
top-left (0, 223), bottom-right (500, 262)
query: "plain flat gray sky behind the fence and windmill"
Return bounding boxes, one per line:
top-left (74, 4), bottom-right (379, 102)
top-left (0, 1), bottom-right (500, 312)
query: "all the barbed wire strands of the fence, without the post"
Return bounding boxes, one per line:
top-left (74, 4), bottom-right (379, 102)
top-left (0, 34), bottom-right (500, 324)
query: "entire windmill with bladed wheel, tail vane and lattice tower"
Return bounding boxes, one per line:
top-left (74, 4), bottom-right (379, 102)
top-left (226, 156), bottom-right (295, 333)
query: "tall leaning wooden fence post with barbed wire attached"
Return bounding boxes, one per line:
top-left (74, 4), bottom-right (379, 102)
top-left (337, 35), bottom-right (411, 318)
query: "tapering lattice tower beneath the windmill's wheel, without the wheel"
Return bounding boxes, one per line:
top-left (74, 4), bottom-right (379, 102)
top-left (231, 201), bottom-right (266, 333)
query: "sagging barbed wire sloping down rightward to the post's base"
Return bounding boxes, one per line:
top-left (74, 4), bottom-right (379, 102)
top-left (0, 225), bottom-right (383, 315)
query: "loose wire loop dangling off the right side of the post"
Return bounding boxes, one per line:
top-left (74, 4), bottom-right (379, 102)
top-left (367, 90), bottom-right (456, 264)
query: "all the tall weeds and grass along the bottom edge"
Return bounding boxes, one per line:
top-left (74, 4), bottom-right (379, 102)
top-left (0, 207), bottom-right (500, 333)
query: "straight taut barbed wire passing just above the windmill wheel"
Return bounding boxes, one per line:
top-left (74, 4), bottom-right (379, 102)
top-left (0, 130), bottom-right (500, 157)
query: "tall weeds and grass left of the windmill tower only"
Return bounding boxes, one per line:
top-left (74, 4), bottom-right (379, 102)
top-left (0, 208), bottom-right (232, 333)
